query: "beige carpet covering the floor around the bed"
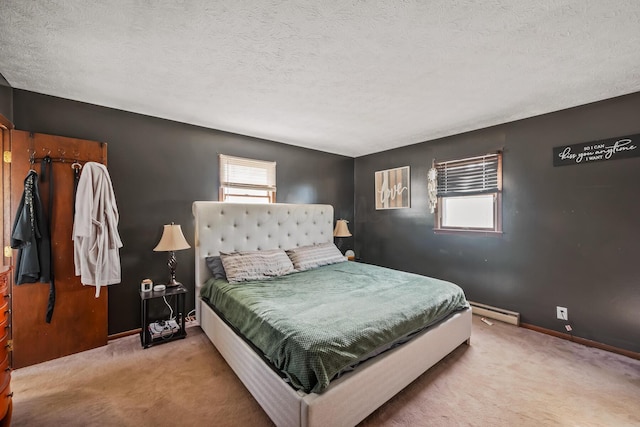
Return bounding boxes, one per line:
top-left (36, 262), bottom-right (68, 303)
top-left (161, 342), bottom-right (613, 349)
top-left (12, 316), bottom-right (640, 426)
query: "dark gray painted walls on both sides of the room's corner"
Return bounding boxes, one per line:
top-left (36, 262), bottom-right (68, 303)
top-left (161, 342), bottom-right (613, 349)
top-left (7, 85), bottom-right (640, 352)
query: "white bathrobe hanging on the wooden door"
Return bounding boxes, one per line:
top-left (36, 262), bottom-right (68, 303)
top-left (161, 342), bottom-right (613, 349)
top-left (73, 162), bottom-right (122, 298)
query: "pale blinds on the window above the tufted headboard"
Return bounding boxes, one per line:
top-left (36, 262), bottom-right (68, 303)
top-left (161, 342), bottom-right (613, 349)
top-left (220, 154), bottom-right (276, 191)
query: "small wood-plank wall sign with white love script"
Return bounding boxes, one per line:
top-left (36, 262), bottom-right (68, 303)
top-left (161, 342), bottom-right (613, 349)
top-left (375, 166), bottom-right (411, 210)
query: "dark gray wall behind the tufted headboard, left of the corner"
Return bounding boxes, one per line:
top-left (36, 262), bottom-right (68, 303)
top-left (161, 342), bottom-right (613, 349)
top-left (13, 90), bottom-right (354, 334)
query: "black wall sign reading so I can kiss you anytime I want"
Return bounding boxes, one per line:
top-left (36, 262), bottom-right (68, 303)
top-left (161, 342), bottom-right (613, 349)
top-left (553, 134), bottom-right (640, 166)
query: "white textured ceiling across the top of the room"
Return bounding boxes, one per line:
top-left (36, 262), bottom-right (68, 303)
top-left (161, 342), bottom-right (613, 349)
top-left (0, 0), bottom-right (640, 156)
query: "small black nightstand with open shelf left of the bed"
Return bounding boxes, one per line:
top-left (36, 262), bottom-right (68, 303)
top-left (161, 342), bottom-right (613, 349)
top-left (140, 285), bottom-right (188, 348)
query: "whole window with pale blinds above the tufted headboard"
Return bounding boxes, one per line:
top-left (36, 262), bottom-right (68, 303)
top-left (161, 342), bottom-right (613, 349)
top-left (219, 154), bottom-right (276, 203)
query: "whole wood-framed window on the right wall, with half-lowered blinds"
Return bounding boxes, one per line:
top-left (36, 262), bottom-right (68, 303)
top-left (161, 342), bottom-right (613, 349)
top-left (435, 153), bottom-right (502, 232)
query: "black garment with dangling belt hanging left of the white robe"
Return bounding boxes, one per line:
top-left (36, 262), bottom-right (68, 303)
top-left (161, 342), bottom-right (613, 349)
top-left (11, 166), bottom-right (55, 323)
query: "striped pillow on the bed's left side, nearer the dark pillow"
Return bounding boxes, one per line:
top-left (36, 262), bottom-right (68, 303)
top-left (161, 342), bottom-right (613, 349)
top-left (220, 249), bottom-right (295, 283)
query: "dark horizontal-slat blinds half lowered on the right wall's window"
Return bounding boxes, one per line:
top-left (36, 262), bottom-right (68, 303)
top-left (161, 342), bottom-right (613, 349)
top-left (435, 153), bottom-right (502, 197)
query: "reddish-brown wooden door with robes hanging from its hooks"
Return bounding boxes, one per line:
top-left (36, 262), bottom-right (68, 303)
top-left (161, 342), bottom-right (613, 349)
top-left (5, 130), bottom-right (108, 368)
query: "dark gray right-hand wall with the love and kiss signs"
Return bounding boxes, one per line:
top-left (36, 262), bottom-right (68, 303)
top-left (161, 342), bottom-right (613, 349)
top-left (355, 93), bottom-right (640, 352)
